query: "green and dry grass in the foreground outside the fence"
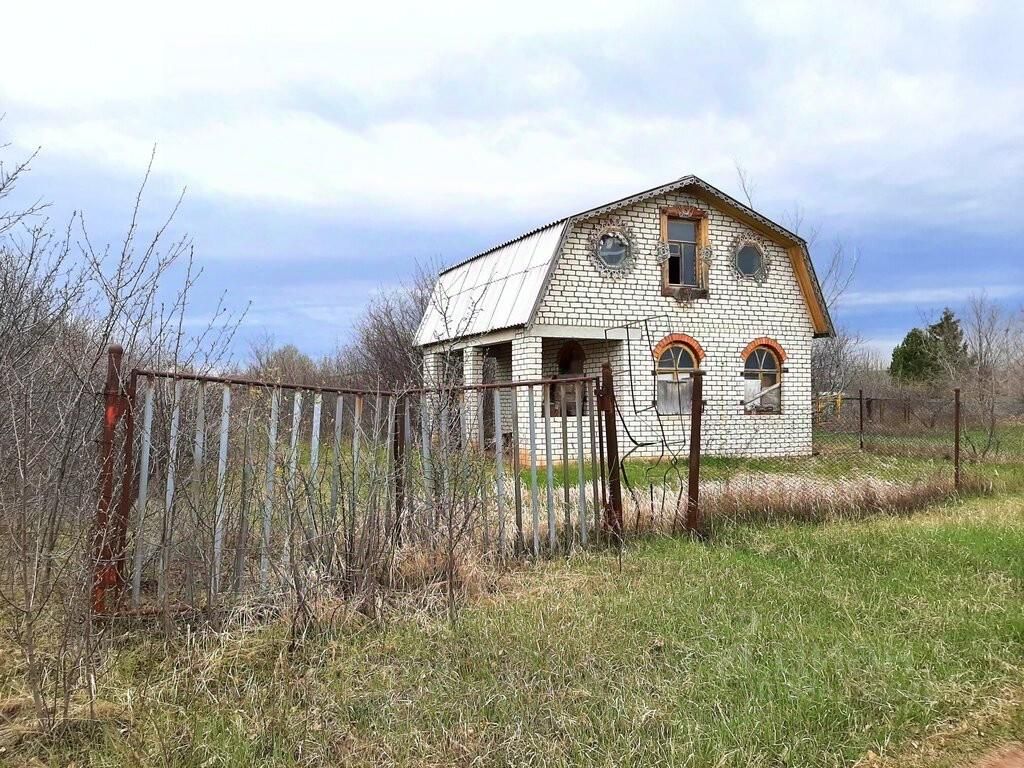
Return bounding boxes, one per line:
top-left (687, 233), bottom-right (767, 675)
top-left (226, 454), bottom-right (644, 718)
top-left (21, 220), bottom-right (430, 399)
top-left (0, 496), bottom-right (1024, 766)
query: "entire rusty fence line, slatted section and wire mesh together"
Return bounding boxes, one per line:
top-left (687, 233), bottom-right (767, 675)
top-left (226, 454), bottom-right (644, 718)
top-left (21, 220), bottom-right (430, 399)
top-left (93, 342), bottom-right (1024, 612)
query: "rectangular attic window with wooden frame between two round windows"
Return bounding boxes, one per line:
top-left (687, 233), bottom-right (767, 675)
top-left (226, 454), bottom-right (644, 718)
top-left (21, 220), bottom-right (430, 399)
top-left (662, 206), bottom-right (708, 299)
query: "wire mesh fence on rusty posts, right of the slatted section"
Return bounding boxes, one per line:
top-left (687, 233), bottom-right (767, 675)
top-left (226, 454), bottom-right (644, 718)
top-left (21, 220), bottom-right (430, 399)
top-left (606, 382), bottom-right (1024, 534)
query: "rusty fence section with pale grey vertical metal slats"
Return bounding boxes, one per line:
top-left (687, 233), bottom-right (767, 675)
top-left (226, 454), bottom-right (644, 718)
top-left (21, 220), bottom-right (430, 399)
top-left (93, 349), bottom-right (622, 612)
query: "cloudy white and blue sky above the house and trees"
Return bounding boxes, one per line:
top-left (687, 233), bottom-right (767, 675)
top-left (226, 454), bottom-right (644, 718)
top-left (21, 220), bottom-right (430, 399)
top-left (0, 0), bottom-right (1024, 353)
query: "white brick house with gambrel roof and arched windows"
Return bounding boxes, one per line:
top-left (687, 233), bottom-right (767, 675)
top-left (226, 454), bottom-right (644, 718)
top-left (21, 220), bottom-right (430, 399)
top-left (417, 176), bottom-right (833, 456)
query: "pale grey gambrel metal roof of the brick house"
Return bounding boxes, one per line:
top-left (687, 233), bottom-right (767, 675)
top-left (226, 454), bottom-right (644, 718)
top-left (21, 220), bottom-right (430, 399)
top-left (416, 175), bottom-right (831, 346)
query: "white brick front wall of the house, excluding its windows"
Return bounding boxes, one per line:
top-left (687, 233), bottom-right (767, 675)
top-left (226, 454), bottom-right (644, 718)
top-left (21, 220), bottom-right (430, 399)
top-left (535, 195), bottom-right (813, 456)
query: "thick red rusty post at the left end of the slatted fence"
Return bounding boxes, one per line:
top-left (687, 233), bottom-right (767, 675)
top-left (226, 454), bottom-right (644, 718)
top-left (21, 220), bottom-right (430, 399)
top-left (92, 344), bottom-right (124, 613)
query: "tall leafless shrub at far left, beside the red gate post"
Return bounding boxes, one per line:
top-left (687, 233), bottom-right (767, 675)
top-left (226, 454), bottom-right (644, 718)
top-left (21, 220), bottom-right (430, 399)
top-left (0, 145), bottom-right (241, 729)
